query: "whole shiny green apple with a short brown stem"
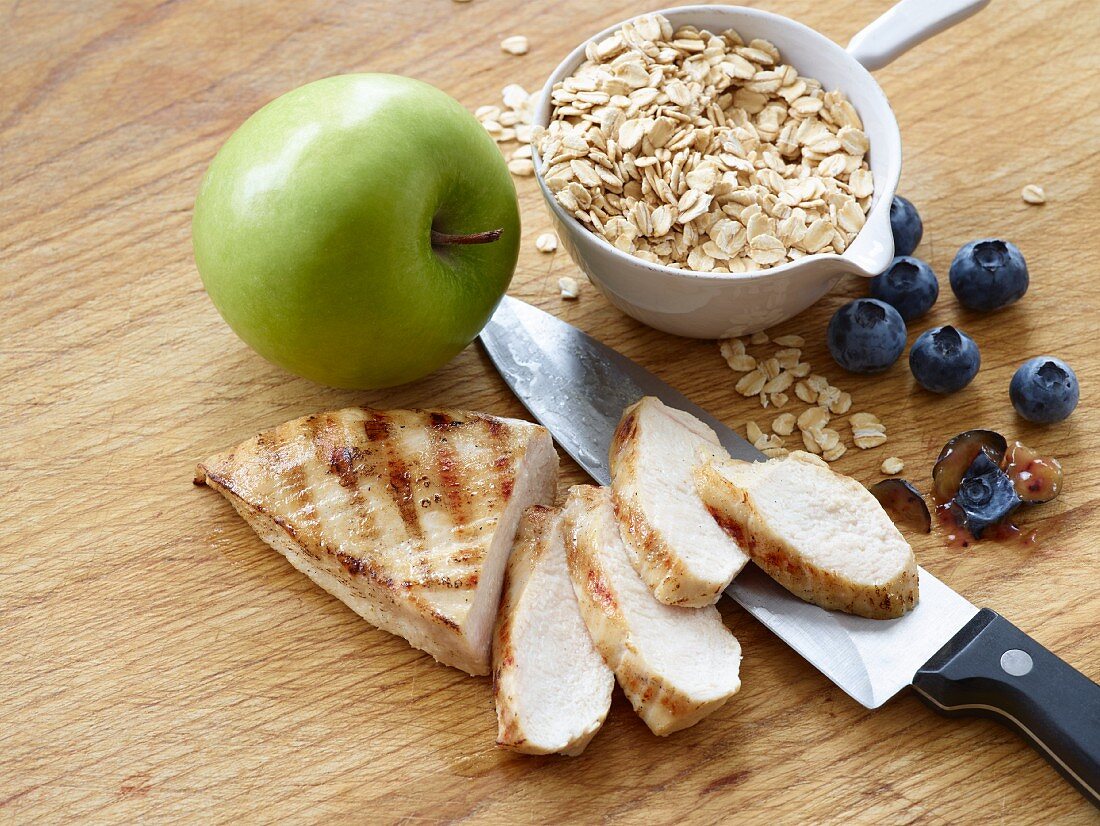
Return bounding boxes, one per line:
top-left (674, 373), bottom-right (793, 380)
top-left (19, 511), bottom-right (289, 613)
top-left (191, 75), bottom-right (519, 388)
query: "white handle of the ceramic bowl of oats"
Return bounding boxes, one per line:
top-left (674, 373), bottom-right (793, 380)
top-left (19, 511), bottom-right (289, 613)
top-left (848, 0), bottom-right (989, 71)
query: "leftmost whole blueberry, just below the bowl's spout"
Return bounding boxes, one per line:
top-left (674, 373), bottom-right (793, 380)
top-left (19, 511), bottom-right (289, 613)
top-left (826, 298), bottom-right (905, 373)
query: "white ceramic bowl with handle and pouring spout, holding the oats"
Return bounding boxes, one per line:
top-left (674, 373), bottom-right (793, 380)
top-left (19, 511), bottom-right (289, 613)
top-left (535, 0), bottom-right (988, 339)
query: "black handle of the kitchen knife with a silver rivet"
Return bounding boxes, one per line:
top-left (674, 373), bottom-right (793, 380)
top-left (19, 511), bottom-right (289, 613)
top-left (913, 608), bottom-right (1100, 807)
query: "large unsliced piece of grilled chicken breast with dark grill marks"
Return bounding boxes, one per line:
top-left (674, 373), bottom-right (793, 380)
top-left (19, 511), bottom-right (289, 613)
top-left (196, 408), bottom-right (558, 674)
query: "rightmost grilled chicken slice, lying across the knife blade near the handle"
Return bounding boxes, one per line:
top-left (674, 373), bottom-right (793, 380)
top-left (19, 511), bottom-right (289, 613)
top-left (696, 451), bottom-right (917, 619)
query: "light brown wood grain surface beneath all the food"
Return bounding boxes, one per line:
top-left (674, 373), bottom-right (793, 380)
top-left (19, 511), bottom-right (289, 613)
top-left (0, 0), bottom-right (1100, 824)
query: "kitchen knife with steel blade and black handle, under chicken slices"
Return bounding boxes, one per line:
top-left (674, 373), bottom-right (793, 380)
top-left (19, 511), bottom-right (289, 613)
top-left (481, 297), bottom-right (1100, 807)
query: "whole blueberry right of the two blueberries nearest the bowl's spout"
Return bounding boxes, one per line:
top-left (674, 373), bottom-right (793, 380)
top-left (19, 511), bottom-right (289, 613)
top-left (949, 238), bottom-right (1029, 312)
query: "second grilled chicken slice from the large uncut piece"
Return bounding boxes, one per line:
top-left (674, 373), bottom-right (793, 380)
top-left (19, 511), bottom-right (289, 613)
top-left (562, 485), bottom-right (741, 735)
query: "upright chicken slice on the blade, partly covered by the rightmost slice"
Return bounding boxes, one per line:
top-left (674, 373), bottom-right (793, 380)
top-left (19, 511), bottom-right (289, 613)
top-left (611, 396), bottom-right (748, 606)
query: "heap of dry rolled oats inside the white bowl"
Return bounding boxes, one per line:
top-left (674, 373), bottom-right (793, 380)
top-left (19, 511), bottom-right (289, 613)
top-left (534, 14), bottom-right (873, 273)
